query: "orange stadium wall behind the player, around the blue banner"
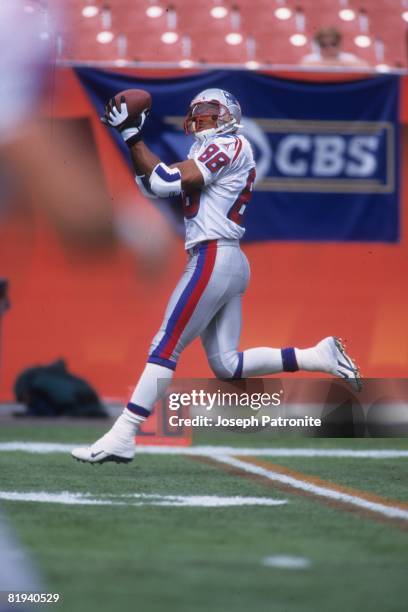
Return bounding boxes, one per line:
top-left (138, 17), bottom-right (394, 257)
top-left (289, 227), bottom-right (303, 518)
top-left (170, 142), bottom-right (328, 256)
top-left (0, 69), bottom-right (408, 400)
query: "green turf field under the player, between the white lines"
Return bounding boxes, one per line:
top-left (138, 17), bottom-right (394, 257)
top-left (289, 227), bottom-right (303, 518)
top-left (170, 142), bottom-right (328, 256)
top-left (0, 422), bottom-right (408, 612)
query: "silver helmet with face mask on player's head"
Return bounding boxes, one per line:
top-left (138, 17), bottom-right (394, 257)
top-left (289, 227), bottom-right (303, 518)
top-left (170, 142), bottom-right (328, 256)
top-left (184, 89), bottom-right (241, 140)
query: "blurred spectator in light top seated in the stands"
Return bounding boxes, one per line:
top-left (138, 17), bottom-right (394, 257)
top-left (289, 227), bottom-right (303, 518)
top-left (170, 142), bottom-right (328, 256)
top-left (301, 28), bottom-right (368, 68)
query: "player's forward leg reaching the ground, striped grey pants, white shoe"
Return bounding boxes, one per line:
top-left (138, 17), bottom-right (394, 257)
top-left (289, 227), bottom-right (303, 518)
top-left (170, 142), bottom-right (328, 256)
top-left (72, 242), bottom-right (228, 463)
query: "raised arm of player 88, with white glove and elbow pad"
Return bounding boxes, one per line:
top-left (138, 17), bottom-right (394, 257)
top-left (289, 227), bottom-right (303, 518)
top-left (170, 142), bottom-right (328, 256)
top-left (102, 97), bottom-right (204, 197)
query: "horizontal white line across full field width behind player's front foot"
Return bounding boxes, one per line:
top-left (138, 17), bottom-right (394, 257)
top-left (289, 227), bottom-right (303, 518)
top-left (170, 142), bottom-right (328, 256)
top-left (0, 441), bottom-right (408, 459)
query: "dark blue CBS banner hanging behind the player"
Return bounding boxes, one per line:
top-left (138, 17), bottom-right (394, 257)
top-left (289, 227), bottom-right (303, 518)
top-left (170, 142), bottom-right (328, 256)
top-left (77, 68), bottom-right (399, 242)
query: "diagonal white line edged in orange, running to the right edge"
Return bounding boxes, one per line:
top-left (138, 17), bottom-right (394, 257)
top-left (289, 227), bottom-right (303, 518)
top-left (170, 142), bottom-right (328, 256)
top-left (213, 455), bottom-right (408, 521)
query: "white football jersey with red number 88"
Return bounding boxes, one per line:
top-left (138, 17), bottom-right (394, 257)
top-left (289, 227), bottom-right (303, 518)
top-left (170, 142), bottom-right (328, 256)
top-left (183, 134), bottom-right (255, 249)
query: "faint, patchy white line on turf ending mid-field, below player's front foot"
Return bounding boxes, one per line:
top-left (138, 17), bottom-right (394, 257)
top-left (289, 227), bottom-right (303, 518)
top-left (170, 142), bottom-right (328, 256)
top-left (0, 491), bottom-right (287, 508)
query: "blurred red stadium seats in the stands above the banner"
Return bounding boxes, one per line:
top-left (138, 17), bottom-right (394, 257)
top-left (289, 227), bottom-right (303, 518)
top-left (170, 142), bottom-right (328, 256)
top-left (51, 0), bottom-right (407, 67)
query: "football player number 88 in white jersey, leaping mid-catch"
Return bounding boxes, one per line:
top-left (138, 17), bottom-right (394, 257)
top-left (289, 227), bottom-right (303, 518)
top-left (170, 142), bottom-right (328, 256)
top-left (72, 89), bottom-right (361, 463)
